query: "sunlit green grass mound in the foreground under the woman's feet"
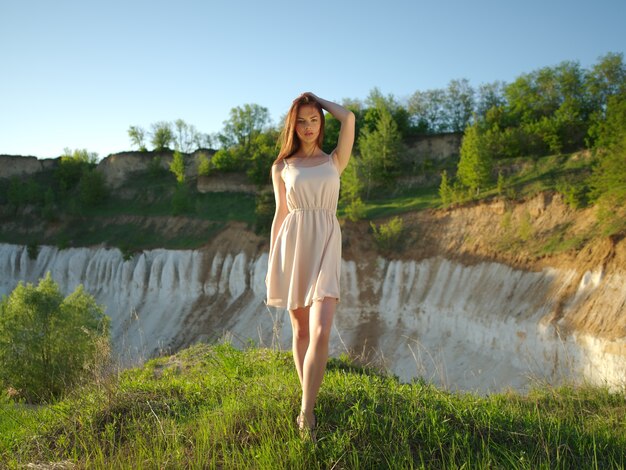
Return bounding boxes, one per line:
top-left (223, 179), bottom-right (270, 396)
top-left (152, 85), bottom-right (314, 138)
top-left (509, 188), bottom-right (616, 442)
top-left (0, 345), bottom-right (626, 469)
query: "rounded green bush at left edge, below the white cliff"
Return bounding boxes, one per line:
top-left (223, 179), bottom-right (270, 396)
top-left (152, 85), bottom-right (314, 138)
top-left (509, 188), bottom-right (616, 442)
top-left (0, 273), bottom-right (109, 402)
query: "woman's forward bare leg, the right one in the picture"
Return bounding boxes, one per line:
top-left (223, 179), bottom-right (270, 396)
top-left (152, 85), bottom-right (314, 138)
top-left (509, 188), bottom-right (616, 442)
top-left (301, 297), bottom-right (337, 425)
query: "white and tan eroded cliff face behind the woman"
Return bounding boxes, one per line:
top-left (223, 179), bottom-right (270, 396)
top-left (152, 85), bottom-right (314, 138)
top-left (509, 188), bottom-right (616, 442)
top-left (0, 206), bottom-right (626, 392)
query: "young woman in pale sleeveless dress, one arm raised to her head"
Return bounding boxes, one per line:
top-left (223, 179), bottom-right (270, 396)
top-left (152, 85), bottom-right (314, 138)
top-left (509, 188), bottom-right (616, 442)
top-left (266, 93), bottom-right (355, 438)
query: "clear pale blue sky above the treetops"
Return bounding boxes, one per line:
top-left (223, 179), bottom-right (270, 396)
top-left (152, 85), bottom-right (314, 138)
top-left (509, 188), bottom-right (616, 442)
top-left (0, 0), bottom-right (626, 158)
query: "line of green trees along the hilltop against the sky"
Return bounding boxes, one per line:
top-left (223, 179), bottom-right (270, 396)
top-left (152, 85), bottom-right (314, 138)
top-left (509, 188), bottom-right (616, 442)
top-left (128, 53), bottom-right (626, 199)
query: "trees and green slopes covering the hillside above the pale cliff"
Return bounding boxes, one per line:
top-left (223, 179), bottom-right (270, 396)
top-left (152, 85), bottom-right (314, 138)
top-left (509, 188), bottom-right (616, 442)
top-left (0, 54), bottom-right (626, 256)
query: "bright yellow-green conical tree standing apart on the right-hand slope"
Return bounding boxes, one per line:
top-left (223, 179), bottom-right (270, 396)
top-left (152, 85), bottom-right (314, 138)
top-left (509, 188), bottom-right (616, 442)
top-left (457, 124), bottom-right (493, 194)
